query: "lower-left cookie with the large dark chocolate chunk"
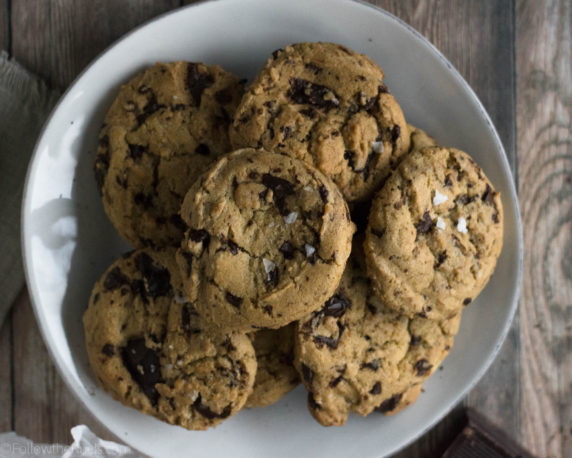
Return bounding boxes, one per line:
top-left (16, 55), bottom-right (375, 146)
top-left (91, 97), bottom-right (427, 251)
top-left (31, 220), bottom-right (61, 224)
top-left (83, 249), bottom-right (256, 429)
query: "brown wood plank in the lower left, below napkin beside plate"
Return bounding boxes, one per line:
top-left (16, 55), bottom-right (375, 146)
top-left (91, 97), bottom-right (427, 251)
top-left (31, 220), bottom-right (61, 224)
top-left (12, 293), bottom-right (112, 444)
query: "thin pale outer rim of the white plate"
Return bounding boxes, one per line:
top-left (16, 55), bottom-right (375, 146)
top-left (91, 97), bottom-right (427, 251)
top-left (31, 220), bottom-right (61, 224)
top-left (20, 0), bottom-right (524, 456)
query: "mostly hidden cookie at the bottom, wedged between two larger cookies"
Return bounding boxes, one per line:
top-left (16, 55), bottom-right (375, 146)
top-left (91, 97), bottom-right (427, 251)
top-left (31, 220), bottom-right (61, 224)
top-left (245, 324), bottom-right (300, 408)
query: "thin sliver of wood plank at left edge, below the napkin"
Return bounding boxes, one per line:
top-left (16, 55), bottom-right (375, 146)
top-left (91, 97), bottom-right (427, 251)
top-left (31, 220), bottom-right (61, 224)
top-left (0, 313), bottom-right (12, 431)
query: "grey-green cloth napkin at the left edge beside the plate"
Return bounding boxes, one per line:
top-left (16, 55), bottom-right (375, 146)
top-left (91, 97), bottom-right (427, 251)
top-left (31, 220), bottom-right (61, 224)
top-left (0, 51), bottom-right (60, 327)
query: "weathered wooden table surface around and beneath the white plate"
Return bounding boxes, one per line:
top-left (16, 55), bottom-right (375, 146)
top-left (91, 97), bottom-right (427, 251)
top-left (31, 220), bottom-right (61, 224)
top-left (0, 0), bottom-right (572, 457)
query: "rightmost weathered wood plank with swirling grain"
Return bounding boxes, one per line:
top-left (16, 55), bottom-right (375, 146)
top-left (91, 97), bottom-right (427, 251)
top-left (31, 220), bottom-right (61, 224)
top-left (516, 0), bottom-right (572, 457)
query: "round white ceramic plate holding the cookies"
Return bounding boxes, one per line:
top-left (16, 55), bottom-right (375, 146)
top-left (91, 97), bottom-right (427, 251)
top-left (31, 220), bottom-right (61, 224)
top-left (22, 0), bottom-right (522, 458)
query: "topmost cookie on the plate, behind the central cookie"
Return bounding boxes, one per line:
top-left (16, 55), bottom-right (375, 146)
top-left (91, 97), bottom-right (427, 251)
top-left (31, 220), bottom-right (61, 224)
top-left (230, 43), bottom-right (409, 202)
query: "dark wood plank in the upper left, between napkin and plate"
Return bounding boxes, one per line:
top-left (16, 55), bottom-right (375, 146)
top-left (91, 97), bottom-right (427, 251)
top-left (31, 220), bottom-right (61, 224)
top-left (12, 0), bottom-right (179, 88)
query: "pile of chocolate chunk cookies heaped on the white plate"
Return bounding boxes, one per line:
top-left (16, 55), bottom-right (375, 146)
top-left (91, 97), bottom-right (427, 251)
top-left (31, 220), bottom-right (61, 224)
top-left (84, 43), bottom-right (503, 430)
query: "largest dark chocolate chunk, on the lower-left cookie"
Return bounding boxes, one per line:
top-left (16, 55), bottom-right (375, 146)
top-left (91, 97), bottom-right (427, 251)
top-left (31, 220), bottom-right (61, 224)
top-left (121, 337), bottom-right (162, 405)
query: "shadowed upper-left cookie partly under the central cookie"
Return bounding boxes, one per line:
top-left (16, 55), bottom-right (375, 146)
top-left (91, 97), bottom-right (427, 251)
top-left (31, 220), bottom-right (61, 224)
top-left (95, 62), bottom-right (243, 248)
